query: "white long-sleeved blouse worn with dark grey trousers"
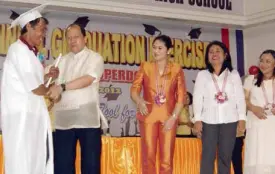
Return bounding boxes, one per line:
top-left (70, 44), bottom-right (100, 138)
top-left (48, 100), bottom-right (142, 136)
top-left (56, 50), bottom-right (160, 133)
top-left (193, 70), bottom-right (246, 124)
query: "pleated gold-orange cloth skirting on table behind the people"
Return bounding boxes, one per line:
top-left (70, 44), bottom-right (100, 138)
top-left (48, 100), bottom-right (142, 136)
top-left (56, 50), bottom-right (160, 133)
top-left (0, 137), bottom-right (234, 174)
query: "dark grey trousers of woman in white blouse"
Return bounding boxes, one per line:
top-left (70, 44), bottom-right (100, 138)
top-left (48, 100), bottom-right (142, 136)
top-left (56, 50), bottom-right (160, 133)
top-left (200, 122), bottom-right (237, 174)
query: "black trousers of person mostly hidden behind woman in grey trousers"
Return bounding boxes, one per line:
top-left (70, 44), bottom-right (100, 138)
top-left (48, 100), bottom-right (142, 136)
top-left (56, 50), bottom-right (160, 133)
top-left (232, 137), bottom-right (244, 174)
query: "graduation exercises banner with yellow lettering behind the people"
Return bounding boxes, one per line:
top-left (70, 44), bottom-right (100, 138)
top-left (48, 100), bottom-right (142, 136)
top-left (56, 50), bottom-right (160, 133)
top-left (0, 8), bottom-right (244, 136)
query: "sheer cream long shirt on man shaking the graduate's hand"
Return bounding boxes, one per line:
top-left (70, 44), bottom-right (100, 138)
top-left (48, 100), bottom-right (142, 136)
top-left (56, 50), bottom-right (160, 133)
top-left (54, 47), bottom-right (106, 129)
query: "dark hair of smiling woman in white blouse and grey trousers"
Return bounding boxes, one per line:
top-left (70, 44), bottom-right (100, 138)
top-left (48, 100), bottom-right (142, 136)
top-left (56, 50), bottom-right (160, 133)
top-left (205, 40), bottom-right (233, 74)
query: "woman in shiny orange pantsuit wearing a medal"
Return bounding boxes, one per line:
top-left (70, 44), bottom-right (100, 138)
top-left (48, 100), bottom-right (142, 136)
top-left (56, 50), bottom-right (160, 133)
top-left (131, 35), bottom-right (186, 174)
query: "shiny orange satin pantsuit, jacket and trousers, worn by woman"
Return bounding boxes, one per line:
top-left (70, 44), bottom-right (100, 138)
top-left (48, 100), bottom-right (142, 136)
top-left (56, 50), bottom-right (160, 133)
top-left (131, 62), bottom-right (186, 174)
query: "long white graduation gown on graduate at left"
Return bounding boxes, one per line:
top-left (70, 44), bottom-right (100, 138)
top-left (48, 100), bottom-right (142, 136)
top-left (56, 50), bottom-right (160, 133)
top-left (1, 40), bottom-right (53, 174)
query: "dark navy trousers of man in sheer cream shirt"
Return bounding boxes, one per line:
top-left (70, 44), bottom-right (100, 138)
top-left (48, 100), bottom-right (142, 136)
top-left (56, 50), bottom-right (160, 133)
top-left (53, 128), bottom-right (101, 174)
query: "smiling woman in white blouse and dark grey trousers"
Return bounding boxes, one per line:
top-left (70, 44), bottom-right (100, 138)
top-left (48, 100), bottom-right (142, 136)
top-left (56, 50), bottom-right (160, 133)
top-left (193, 41), bottom-right (246, 174)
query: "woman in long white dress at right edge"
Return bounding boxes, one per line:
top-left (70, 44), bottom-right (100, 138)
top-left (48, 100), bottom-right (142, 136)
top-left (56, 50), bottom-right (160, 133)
top-left (244, 50), bottom-right (275, 174)
